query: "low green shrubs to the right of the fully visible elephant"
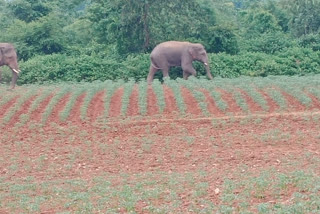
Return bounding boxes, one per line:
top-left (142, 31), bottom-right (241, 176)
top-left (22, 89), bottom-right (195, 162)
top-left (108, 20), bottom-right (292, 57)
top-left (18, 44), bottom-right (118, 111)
top-left (209, 47), bottom-right (320, 77)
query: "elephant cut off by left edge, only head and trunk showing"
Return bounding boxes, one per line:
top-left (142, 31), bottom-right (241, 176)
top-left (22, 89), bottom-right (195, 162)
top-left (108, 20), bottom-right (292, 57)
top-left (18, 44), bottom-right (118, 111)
top-left (0, 43), bottom-right (21, 89)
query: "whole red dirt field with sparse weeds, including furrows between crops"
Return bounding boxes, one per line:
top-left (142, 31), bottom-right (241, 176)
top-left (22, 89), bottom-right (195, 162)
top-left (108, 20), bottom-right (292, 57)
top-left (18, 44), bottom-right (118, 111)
top-left (0, 81), bottom-right (320, 213)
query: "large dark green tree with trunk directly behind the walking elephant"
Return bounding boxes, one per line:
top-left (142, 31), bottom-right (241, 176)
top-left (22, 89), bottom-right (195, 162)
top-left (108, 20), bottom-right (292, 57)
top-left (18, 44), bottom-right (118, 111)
top-left (88, 0), bottom-right (216, 54)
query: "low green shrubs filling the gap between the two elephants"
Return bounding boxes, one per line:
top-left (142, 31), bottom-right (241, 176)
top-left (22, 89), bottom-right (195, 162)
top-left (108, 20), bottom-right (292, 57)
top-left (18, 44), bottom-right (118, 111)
top-left (19, 54), bottom-right (149, 84)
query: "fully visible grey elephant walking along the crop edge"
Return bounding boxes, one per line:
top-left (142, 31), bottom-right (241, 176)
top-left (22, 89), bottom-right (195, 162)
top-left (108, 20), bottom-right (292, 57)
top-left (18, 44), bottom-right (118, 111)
top-left (147, 41), bottom-right (212, 84)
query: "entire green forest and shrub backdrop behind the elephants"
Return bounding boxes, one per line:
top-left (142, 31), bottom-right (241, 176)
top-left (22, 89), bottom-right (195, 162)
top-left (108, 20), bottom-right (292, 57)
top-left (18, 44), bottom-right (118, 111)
top-left (0, 0), bottom-right (320, 84)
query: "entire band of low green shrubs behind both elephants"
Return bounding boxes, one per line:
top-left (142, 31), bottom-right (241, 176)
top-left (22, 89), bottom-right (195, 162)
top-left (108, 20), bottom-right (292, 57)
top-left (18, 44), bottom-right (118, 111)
top-left (18, 47), bottom-right (320, 84)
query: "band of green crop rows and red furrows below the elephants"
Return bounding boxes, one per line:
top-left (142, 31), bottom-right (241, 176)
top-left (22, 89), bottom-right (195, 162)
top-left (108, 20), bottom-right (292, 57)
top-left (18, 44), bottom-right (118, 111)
top-left (0, 75), bottom-right (320, 126)
